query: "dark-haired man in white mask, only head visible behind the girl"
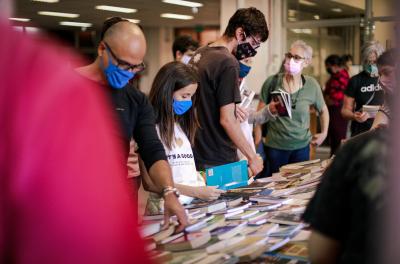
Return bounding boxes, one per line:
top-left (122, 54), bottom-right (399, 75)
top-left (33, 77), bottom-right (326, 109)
top-left (172, 36), bottom-right (199, 64)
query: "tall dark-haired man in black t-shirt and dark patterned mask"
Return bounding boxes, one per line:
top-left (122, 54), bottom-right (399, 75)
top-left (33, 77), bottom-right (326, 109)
top-left (190, 7), bottom-right (268, 175)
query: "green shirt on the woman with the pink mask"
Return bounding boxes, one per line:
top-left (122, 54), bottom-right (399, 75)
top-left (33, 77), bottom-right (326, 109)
top-left (261, 74), bottom-right (325, 150)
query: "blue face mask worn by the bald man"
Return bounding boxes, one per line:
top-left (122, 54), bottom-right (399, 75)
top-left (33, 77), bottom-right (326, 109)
top-left (100, 49), bottom-right (135, 89)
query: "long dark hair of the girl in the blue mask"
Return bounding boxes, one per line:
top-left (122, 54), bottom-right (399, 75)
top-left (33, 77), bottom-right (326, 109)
top-left (149, 61), bottom-right (199, 149)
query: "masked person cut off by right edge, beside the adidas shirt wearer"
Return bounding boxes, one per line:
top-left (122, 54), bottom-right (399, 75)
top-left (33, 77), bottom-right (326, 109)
top-left (371, 49), bottom-right (399, 129)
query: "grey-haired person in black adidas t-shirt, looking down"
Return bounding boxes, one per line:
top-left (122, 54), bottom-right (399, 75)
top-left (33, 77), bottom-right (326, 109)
top-left (341, 41), bottom-right (383, 137)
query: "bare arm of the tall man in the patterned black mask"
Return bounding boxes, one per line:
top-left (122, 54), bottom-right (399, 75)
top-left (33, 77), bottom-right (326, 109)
top-left (220, 103), bottom-right (263, 175)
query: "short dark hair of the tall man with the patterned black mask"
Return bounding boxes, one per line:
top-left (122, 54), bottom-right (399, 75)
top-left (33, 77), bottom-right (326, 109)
top-left (224, 7), bottom-right (269, 42)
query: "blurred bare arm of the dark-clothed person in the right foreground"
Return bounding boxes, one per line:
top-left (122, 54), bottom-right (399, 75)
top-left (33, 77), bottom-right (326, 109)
top-left (308, 230), bottom-right (340, 264)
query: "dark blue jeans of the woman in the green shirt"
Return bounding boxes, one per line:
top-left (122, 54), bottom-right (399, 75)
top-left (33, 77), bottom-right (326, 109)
top-left (265, 145), bottom-right (310, 175)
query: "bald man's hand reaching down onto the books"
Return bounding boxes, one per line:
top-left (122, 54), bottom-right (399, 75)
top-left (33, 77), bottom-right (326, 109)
top-left (163, 193), bottom-right (189, 233)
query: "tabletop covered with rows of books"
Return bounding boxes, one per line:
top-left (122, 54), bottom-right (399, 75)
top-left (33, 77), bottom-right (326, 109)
top-left (141, 160), bottom-right (329, 264)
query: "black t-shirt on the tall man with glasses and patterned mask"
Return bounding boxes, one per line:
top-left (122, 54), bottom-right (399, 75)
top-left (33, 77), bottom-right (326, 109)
top-left (190, 46), bottom-right (241, 170)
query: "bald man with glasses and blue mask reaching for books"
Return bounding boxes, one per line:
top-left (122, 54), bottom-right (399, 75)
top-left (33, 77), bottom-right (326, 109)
top-left (77, 18), bottom-right (187, 231)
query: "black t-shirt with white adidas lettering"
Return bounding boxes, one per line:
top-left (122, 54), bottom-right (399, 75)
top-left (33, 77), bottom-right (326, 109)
top-left (345, 71), bottom-right (384, 136)
